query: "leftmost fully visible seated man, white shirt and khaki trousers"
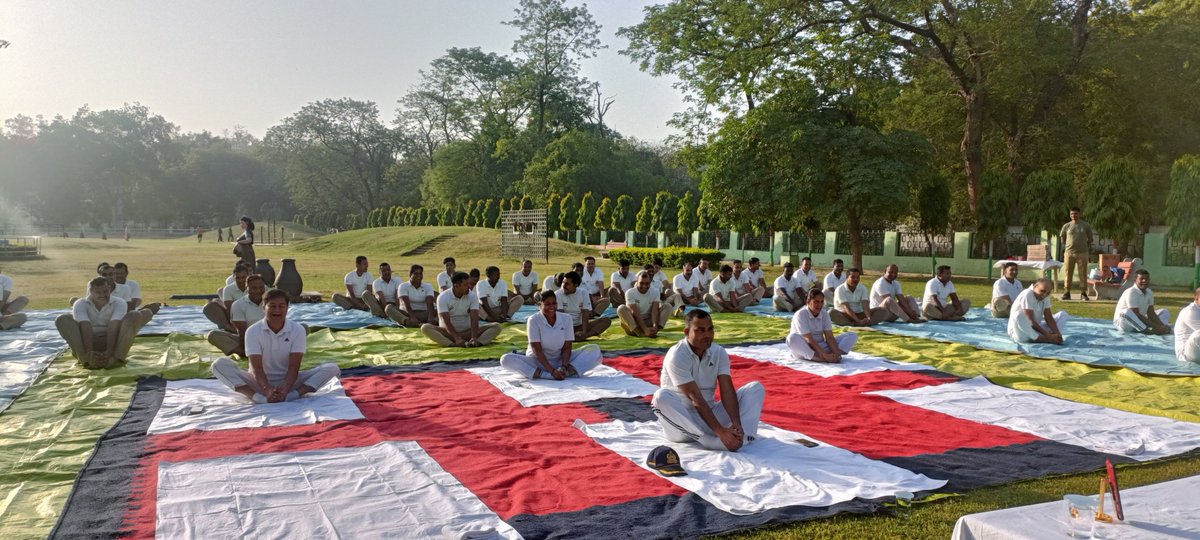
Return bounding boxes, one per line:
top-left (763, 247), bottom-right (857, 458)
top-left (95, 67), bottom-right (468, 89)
top-left (54, 276), bottom-right (152, 370)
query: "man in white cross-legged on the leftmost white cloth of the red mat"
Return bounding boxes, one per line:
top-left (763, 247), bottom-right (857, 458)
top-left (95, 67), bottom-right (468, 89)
top-left (212, 289), bottom-right (342, 403)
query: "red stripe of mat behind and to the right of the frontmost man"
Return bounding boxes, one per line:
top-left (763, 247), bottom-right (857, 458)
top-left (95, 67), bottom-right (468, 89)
top-left (605, 355), bottom-right (1042, 460)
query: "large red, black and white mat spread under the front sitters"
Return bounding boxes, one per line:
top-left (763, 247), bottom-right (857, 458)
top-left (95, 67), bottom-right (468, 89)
top-left (46, 346), bottom-right (1200, 538)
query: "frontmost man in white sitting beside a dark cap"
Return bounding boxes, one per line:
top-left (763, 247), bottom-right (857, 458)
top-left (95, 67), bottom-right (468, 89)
top-left (650, 310), bottom-right (767, 451)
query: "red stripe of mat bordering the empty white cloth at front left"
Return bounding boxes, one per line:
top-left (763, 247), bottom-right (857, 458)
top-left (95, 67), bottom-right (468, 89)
top-left (126, 371), bottom-right (686, 538)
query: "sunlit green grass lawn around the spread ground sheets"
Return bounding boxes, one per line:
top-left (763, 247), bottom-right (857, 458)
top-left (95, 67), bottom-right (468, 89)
top-left (0, 227), bottom-right (1200, 539)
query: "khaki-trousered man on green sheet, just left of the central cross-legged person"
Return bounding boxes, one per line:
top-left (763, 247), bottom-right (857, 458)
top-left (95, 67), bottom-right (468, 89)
top-left (421, 272), bottom-right (502, 347)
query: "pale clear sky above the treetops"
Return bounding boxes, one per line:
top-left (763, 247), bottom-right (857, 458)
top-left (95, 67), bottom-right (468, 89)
top-left (0, 0), bottom-right (684, 140)
